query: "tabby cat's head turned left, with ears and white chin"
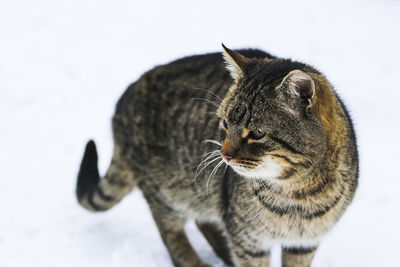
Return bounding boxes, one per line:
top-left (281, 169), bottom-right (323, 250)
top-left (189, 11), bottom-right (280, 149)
top-left (217, 46), bottom-right (326, 179)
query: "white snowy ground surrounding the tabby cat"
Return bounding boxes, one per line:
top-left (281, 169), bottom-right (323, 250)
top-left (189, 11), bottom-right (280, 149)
top-left (0, 0), bottom-right (400, 267)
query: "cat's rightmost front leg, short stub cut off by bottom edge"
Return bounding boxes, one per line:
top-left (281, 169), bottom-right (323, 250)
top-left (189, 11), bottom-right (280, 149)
top-left (282, 247), bottom-right (317, 267)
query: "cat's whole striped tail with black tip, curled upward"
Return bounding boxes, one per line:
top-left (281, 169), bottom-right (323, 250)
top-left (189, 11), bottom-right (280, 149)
top-left (76, 140), bottom-right (135, 211)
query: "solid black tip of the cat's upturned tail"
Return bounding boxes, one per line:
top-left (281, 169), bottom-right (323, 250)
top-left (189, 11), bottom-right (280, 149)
top-left (76, 140), bottom-right (100, 199)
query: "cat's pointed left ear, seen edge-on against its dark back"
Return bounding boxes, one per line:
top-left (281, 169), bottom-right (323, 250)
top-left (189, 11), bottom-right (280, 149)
top-left (222, 44), bottom-right (250, 82)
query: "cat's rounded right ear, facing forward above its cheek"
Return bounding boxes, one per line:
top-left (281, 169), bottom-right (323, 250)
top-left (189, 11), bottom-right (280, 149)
top-left (279, 70), bottom-right (315, 112)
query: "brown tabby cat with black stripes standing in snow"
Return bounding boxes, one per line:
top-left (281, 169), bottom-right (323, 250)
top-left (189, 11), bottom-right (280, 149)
top-left (76, 45), bottom-right (358, 267)
